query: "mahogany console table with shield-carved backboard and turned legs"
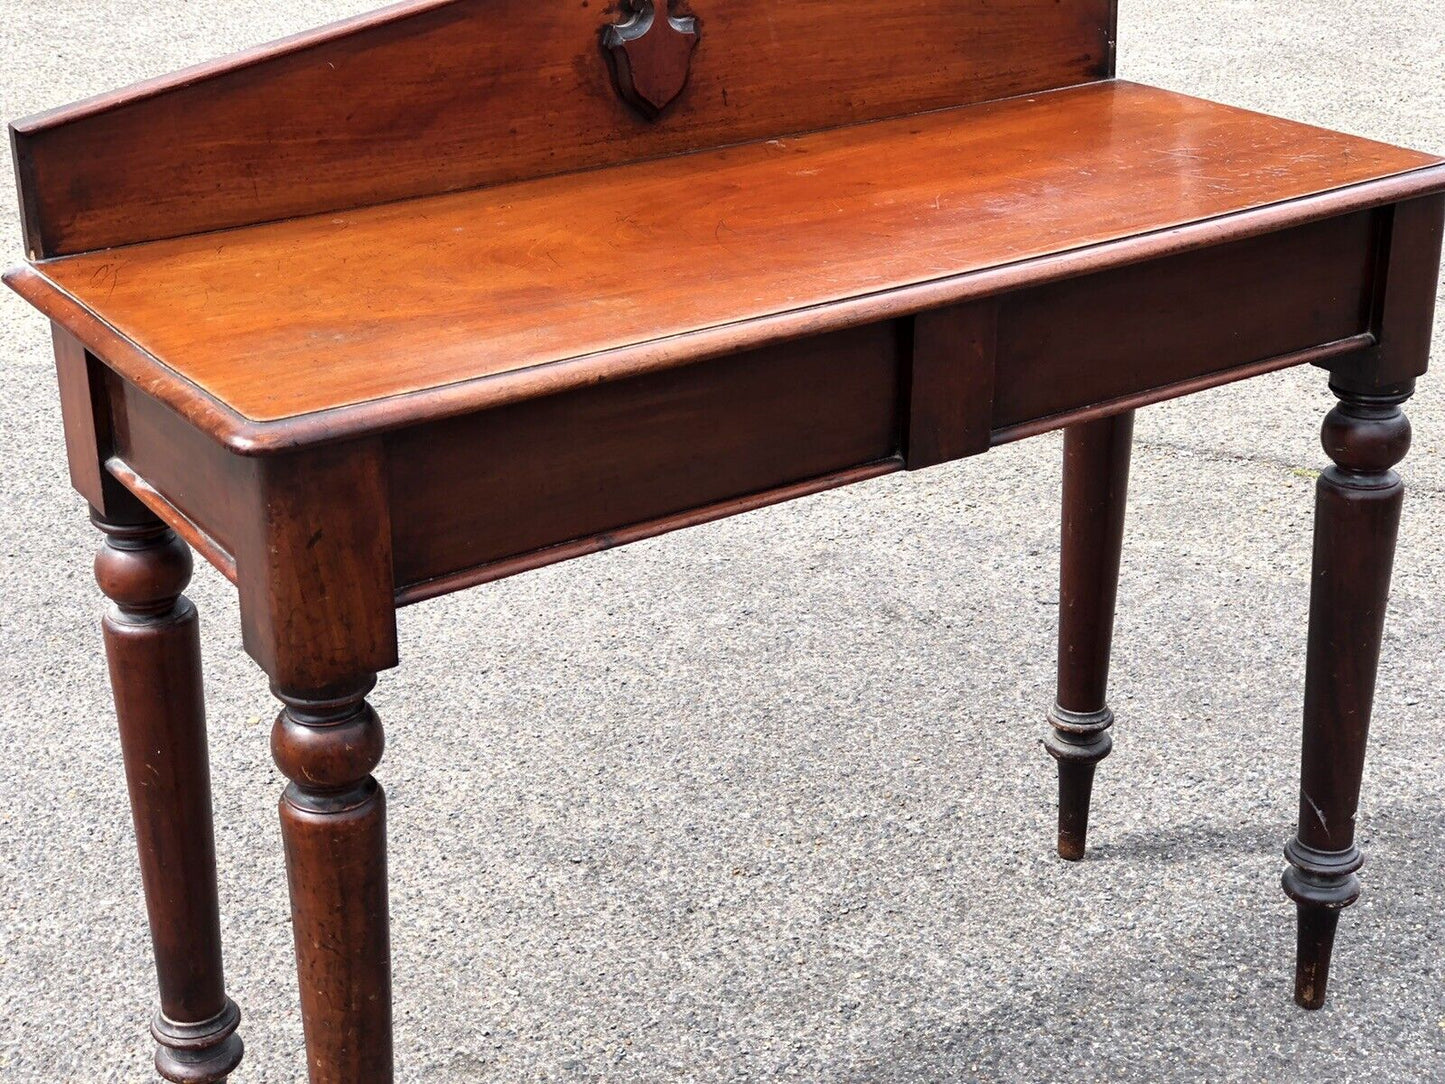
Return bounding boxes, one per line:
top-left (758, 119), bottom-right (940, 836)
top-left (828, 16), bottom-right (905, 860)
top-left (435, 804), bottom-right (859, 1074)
top-left (6, 0), bottom-right (1445, 1084)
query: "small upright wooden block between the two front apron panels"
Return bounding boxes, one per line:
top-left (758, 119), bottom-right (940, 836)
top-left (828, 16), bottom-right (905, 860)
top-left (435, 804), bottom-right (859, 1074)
top-left (906, 301), bottom-right (998, 470)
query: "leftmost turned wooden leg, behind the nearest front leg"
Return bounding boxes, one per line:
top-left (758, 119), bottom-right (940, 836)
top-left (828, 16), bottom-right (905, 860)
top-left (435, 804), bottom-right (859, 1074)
top-left (91, 513), bottom-right (241, 1084)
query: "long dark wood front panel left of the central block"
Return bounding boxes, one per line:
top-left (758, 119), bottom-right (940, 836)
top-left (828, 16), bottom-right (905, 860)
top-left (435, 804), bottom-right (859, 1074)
top-left (386, 324), bottom-right (900, 587)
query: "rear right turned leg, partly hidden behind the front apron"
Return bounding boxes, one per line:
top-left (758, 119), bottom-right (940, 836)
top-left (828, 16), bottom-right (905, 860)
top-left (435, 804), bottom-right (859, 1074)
top-left (1045, 410), bottom-right (1134, 861)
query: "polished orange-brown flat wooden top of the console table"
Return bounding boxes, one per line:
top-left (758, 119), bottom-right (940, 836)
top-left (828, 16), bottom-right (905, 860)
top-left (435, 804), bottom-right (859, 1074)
top-left (5, 81), bottom-right (1445, 442)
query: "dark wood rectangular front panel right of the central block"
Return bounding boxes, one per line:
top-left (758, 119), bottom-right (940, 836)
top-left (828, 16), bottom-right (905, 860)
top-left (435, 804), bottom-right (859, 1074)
top-left (994, 212), bottom-right (1379, 429)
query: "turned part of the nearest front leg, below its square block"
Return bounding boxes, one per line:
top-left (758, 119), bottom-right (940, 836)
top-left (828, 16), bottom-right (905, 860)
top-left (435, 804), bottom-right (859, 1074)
top-left (272, 679), bottom-right (393, 1084)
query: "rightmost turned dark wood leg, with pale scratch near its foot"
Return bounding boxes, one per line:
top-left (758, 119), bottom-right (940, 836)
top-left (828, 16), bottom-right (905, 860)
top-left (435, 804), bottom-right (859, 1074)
top-left (1283, 386), bottom-right (1412, 1009)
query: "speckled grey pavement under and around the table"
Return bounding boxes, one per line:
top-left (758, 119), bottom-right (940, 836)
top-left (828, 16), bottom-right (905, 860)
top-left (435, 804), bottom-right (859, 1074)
top-left (0, 0), bottom-right (1445, 1084)
